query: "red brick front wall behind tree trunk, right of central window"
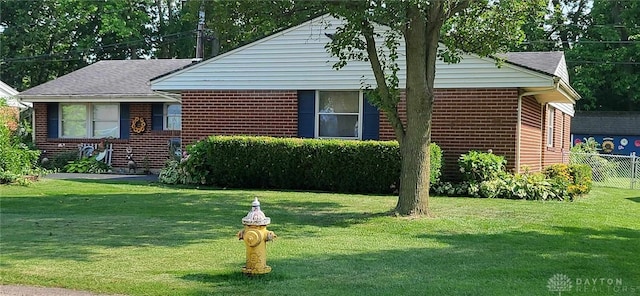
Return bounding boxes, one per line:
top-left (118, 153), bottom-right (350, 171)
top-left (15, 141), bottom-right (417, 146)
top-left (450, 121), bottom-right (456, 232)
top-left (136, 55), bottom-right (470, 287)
top-left (380, 88), bottom-right (518, 178)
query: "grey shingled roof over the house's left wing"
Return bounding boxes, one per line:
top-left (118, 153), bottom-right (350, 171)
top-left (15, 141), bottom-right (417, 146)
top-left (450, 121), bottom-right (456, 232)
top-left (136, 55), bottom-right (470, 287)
top-left (19, 59), bottom-right (191, 100)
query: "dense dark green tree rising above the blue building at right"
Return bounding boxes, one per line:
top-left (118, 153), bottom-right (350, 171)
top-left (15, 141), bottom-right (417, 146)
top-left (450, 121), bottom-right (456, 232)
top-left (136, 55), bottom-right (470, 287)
top-left (567, 1), bottom-right (640, 111)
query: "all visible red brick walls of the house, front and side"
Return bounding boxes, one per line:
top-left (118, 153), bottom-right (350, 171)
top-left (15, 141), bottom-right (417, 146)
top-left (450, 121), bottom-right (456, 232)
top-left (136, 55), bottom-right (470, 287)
top-left (34, 88), bottom-right (571, 176)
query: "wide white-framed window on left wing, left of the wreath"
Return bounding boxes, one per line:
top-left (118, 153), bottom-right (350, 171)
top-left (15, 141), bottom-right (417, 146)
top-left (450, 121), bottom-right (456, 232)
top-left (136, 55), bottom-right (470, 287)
top-left (60, 104), bottom-right (120, 138)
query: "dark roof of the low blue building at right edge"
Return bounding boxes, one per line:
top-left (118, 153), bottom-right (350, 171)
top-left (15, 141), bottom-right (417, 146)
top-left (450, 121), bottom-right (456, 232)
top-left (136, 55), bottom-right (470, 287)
top-left (571, 111), bottom-right (640, 136)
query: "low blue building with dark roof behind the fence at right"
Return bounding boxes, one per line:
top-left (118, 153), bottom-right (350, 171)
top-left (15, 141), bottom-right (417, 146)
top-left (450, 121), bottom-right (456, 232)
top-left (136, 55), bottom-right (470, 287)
top-left (571, 111), bottom-right (640, 155)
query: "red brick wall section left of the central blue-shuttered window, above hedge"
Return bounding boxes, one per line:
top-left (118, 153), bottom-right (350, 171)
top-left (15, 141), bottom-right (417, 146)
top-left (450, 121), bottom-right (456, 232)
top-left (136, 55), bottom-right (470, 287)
top-left (182, 90), bottom-right (298, 145)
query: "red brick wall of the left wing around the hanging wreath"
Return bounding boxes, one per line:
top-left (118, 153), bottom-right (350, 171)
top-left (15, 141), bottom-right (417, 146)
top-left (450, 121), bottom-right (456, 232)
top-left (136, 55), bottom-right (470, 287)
top-left (33, 103), bottom-right (180, 172)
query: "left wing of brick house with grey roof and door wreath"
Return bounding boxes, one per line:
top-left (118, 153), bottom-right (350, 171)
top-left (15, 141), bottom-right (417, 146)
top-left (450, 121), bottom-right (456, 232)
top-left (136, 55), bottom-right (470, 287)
top-left (18, 59), bottom-right (191, 169)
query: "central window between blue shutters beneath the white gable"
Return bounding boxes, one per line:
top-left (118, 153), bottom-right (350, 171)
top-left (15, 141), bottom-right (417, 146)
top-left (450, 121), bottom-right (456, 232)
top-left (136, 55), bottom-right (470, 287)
top-left (316, 91), bottom-right (362, 139)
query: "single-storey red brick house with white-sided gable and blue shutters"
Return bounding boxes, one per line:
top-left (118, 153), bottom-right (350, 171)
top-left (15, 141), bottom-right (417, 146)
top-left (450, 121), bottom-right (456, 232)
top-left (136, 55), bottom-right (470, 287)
top-left (19, 16), bottom-right (579, 173)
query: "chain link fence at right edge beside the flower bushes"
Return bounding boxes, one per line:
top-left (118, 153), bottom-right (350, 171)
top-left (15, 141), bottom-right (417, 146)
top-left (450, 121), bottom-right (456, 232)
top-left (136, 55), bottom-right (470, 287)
top-left (563, 152), bottom-right (640, 189)
